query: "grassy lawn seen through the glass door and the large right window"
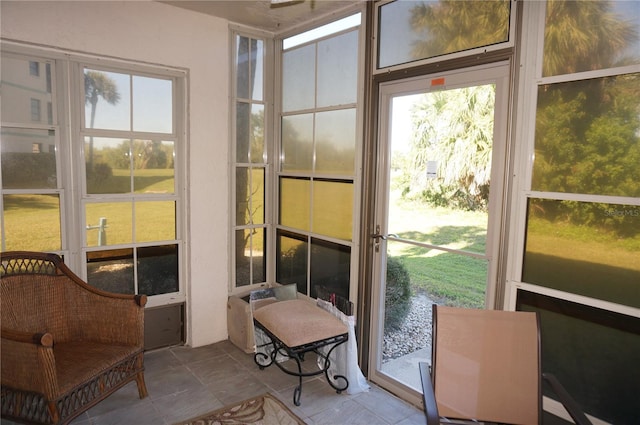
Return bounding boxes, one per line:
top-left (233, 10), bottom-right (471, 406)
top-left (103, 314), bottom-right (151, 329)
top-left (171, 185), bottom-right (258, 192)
top-left (387, 198), bottom-right (640, 307)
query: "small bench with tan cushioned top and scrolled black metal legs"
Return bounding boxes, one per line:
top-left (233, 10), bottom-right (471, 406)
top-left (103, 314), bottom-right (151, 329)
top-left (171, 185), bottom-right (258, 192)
top-left (253, 299), bottom-right (349, 406)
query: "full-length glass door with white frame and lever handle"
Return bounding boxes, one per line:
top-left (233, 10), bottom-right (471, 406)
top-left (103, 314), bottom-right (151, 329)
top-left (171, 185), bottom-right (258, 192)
top-left (369, 63), bottom-right (509, 402)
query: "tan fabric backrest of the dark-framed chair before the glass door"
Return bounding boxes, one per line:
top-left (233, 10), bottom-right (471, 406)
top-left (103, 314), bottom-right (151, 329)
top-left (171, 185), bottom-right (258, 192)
top-left (432, 305), bottom-right (541, 424)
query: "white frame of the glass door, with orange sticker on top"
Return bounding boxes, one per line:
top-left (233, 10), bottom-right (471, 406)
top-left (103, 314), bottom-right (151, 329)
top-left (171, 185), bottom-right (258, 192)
top-left (368, 61), bottom-right (511, 405)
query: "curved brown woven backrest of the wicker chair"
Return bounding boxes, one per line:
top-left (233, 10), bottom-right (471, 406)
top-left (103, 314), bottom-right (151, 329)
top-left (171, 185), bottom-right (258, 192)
top-left (0, 251), bottom-right (146, 347)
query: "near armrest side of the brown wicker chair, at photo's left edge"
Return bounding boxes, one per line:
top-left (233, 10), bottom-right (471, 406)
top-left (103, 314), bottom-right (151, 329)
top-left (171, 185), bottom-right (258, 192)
top-left (0, 328), bottom-right (59, 400)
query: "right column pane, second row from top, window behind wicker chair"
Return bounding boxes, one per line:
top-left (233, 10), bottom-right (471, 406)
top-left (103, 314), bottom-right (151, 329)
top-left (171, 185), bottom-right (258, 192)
top-left (133, 140), bottom-right (175, 193)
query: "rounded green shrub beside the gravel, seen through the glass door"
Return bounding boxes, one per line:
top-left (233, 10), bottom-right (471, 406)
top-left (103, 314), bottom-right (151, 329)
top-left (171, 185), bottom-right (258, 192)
top-left (384, 257), bottom-right (411, 331)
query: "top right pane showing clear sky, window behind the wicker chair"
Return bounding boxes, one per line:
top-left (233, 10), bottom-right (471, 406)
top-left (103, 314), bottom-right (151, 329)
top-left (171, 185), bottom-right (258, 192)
top-left (133, 75), bottom-right (173, 134)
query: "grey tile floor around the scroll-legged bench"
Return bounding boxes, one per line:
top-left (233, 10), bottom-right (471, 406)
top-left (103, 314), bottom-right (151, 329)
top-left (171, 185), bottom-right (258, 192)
top-left (2, 341), bottom-right (426, 425)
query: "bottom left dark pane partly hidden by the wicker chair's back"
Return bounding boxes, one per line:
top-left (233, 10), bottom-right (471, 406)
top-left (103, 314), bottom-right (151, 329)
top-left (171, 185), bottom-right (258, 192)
top-left (87, 248), bottom-right (135, 294)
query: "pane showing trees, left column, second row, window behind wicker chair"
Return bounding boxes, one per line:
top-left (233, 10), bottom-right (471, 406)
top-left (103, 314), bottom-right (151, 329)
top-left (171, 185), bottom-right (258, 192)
top-left (84, 137), bottom-right (131, 194)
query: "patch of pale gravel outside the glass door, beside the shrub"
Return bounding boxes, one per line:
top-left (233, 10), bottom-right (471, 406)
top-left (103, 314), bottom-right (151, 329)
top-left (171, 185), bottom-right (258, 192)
top-left (382, 294), bottom-right (433, 362)
